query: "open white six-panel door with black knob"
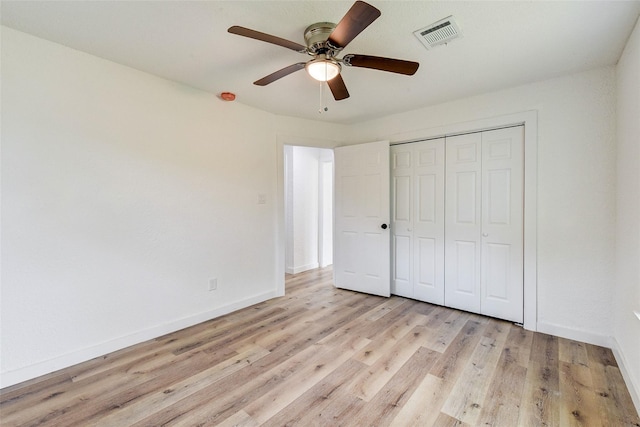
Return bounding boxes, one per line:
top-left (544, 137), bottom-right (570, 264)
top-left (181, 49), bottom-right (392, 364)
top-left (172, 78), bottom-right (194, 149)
top-left (333, 142), bottom-right (391, 297)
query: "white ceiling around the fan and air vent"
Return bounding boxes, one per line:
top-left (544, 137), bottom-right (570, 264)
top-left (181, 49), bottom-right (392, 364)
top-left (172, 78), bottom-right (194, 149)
top-left (1, 0), bottom-right (640, 123)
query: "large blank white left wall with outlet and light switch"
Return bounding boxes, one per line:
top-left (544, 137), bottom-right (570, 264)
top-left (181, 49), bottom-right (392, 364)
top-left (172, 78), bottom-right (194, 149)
top-left (0, 28), bottom-right (342, 386)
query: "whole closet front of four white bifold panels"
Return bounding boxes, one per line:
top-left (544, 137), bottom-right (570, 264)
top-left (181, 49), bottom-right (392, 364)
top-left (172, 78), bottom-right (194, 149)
top-left (391, 126), bottom-right (524, 323)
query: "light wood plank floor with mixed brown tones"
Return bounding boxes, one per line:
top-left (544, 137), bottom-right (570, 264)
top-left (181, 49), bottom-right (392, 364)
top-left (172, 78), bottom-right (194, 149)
top-left (0, 269), bottom-right (640, 427)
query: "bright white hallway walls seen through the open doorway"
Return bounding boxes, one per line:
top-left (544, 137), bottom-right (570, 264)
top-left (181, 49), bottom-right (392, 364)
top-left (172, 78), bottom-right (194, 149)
top-left (284, 145), bottom-right (333, 274)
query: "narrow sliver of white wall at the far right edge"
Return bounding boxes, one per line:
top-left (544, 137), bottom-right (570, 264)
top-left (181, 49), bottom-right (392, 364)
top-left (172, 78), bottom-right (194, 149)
top-left (613, 16), bottom-right (640, 411)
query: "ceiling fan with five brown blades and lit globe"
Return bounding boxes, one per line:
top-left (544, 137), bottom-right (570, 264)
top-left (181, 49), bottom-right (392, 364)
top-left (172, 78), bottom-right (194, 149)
top-left (228, 1), bottom-right (420, 101)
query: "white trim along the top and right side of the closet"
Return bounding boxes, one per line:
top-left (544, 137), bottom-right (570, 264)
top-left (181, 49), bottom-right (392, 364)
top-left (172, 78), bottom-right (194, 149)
top-left (389, 110), bottom-right (538, 331)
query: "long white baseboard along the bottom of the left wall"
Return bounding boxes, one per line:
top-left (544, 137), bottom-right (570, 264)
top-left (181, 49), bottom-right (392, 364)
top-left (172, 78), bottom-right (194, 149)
top-left (0, 291), bottom-right (277, 388)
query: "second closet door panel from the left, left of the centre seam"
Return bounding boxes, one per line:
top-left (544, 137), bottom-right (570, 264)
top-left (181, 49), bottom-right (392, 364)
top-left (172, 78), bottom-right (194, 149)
top-left (412, 138), bottom-right (445, 305)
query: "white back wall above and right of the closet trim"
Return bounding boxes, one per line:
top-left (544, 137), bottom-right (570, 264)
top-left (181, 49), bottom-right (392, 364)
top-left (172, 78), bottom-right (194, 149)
top-left (351, 67), bottom-right (615, 344)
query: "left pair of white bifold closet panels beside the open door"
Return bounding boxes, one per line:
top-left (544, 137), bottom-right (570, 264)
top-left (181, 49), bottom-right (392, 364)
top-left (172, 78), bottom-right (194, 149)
top-left (391, 138), bottom-right (445, 304)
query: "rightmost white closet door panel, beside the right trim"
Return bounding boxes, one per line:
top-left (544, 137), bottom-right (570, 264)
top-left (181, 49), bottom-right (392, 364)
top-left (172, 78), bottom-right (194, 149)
top-left (481, 126), bottom-right (524, 323)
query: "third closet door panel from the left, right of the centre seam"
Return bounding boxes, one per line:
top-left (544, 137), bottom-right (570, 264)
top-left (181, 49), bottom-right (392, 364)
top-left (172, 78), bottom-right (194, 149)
top-left (445, 133), bottom-right (482, 313)
